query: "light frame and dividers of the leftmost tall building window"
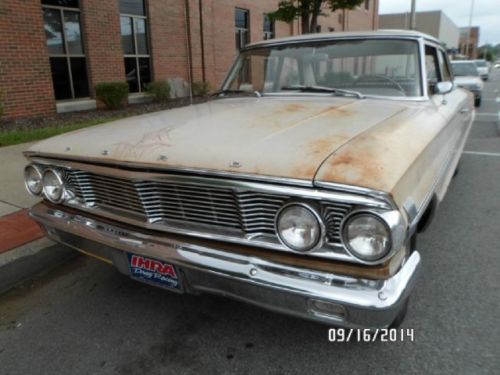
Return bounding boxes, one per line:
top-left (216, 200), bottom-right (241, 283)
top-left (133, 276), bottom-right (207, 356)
top-left (41, 3), bottom-right (90, 101)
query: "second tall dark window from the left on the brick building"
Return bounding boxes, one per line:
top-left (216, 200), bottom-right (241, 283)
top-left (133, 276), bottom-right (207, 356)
top-left (120, 0), bottom-right (151, 92)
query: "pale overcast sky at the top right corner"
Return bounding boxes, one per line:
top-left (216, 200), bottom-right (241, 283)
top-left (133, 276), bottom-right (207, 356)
top-left (379, 0), bottom-right (500, 45)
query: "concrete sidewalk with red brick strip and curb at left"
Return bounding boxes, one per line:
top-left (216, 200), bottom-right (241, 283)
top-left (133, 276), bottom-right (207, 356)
top-left (0, 143), bottom-right (74, 293)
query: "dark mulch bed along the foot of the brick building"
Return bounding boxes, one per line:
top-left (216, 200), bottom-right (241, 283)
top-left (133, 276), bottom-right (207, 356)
top-left (0, 97), bottom-right (208, 132)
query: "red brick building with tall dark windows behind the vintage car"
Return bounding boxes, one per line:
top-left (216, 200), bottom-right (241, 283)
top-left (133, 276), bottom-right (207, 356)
top-left (0, 0), bottom-right (379, 118)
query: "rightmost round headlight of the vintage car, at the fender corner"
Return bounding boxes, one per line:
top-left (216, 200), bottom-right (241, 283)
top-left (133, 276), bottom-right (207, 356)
top-left (343, 214), bottom-right (391, 261)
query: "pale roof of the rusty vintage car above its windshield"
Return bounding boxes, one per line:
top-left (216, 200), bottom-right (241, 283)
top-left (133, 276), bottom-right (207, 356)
top-left (244, 30), bottom-right (443, 49)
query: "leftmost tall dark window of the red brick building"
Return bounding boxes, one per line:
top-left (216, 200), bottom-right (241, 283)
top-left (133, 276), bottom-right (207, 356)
top-left (42, 0), bottom-right (89, 100)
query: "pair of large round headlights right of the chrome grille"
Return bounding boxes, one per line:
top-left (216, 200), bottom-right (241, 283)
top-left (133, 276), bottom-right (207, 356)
top-left (276, 203), bottom-right (392, 263)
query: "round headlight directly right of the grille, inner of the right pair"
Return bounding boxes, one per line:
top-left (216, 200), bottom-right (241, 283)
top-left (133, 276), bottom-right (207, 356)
top-left (276, 204), bottom-right (322, 251)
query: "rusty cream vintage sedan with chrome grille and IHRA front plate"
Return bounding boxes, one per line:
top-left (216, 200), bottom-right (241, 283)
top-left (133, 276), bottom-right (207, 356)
top-left (25, 31), bottom-right (474, 328)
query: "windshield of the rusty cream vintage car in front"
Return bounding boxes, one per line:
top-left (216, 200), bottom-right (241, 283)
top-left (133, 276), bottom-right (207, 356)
top-left (223, 39), bottom-right (422, 97)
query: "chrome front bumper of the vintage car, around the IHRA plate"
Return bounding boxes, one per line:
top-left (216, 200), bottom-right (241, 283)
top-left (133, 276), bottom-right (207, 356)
top-left (30, 203), bottom-right (420, 328)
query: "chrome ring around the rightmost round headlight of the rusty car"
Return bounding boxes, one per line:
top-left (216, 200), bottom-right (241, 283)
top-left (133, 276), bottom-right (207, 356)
top-left (340, 209), bottom-right (397, 265)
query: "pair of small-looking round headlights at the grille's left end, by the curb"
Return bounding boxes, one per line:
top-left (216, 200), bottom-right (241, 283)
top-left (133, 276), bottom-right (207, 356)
top-left (24, 164), bottom-right (65, 203)
